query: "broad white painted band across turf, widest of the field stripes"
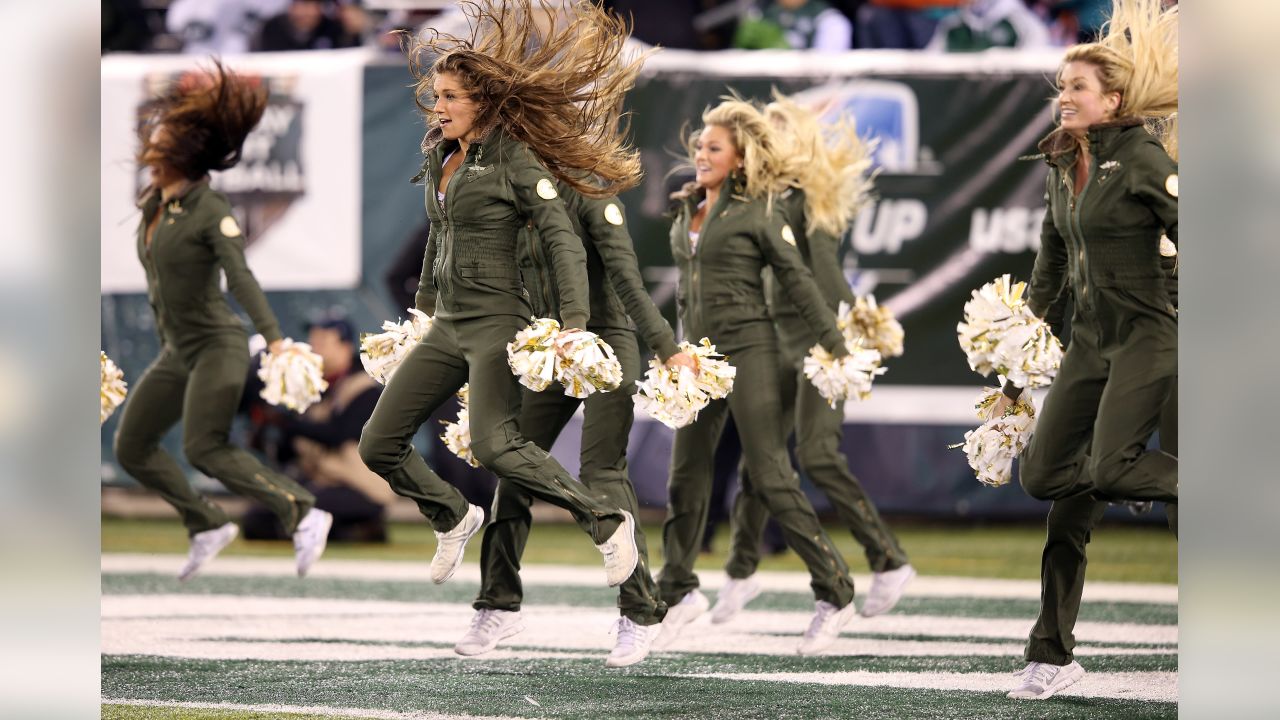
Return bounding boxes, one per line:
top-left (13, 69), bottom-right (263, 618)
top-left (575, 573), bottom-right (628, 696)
top-left (101, 596), bottom-right (1178, 661)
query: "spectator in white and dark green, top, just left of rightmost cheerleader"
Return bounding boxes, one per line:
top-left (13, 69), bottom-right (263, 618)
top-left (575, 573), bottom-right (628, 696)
top-left (925, 0), bottom-right (1050, 53)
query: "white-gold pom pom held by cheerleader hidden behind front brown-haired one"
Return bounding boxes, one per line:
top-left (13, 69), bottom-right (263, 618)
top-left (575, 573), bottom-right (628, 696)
top-left (632, 337), bottom-right (737, 429)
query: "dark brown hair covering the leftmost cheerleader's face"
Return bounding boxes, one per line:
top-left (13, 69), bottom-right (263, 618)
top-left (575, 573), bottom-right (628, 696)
top-left (137, 60), bottom-right (266, 181)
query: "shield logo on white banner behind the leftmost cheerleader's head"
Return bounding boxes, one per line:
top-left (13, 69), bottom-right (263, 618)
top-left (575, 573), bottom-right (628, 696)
top-left (137, 70), bottom-right (306, 243)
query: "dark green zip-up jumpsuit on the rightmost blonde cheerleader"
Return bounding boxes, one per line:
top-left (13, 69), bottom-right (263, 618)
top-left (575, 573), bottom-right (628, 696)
top-left (1019, 120), bottom-right (1178, 665)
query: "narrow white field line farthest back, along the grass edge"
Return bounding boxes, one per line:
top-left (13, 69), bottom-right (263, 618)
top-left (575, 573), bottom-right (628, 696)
top-left (102, 553), bottom-right (1178, 605)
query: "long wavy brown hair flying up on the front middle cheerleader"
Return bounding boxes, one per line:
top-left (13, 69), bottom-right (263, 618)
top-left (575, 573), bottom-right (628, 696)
top-left (406, 0), bottom-right (646, 197)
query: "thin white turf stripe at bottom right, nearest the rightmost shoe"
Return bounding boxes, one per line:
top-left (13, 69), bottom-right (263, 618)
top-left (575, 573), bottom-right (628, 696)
top-left (692, 670), bottom-right (1178, 712)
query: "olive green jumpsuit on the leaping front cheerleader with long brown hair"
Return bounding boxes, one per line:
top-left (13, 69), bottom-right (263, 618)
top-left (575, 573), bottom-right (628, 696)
top-left (360, 127), bottom-right (622, 544)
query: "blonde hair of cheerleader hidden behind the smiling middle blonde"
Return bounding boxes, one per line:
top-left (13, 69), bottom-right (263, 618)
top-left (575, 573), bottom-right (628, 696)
top-left (764, 90), bottom-right (876, 236)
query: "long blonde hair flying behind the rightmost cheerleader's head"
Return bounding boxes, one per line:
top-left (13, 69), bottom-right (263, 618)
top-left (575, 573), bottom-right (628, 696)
top-left (1060, 0), bottom-right (1178, 160)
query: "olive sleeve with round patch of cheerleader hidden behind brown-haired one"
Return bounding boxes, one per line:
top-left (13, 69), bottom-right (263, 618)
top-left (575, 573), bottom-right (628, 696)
top-left (579, 196), bottom-right (680, 363)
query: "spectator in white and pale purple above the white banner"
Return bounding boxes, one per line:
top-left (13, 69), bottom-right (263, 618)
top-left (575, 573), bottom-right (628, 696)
top-left (165, 0), bottom-right (289, 55)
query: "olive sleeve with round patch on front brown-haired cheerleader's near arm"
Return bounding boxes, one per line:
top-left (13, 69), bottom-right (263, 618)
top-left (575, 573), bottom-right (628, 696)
top-left (508, 143), bottom-right (591, 329)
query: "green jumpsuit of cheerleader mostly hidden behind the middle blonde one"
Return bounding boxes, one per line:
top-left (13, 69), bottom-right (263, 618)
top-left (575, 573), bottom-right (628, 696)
top-left (724, 190), bottom-right (908, 579)
